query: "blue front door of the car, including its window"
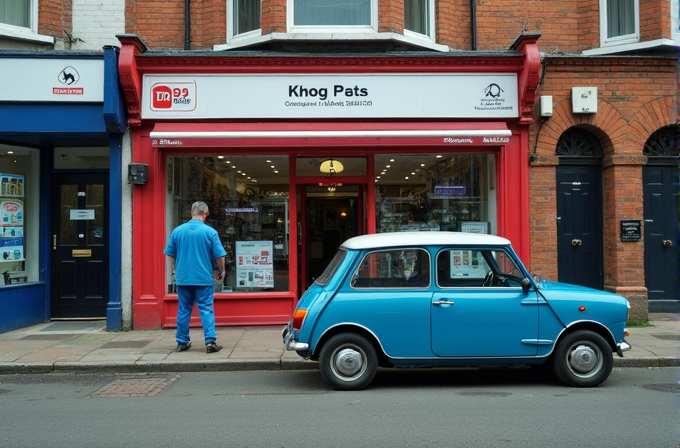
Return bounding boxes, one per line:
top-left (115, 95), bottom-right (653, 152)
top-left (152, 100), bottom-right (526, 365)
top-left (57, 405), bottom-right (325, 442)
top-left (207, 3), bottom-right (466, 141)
top-left (430, 249), bottom-right (539, 358)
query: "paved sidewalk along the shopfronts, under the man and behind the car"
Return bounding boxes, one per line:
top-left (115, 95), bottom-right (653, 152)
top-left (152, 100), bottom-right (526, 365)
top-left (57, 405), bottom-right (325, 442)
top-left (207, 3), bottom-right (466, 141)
top-left (0, 313), bottom-right (680, 374)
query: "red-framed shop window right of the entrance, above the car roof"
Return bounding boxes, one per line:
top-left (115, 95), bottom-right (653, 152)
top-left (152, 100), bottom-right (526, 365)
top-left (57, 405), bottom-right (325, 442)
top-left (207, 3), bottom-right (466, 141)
top-left (375, 154), bottom-right (496, 233)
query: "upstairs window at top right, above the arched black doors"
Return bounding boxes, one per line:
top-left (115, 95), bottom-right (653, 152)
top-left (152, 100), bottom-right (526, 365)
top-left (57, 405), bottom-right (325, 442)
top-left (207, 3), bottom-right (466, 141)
top-left (600, 0), bottom-right (640, 46)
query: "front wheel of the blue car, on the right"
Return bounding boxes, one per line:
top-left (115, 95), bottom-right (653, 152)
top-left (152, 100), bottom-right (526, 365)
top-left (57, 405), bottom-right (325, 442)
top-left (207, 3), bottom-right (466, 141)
top-left (553, 330), bottom-right (614, 387)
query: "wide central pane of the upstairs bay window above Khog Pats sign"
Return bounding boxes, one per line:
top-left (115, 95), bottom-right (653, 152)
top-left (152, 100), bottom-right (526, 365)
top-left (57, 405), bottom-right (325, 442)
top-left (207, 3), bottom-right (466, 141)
top-left (288, 0), bottom-right (377, 32)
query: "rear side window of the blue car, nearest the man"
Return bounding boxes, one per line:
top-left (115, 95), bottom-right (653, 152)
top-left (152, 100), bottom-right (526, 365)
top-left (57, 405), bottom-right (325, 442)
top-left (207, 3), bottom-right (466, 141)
top-left (351, 249), bottom-right (430, 288)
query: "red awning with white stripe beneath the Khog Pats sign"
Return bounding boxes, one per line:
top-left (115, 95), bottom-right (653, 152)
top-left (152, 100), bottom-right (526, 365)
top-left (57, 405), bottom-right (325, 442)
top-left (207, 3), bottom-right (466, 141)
top-left (150, 122), bottom-right (512, 148)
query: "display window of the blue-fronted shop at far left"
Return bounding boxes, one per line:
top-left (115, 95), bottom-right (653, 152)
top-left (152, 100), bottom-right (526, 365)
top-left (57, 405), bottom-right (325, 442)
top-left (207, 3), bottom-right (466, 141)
top-left (0, 145), bottom-right (40, 285)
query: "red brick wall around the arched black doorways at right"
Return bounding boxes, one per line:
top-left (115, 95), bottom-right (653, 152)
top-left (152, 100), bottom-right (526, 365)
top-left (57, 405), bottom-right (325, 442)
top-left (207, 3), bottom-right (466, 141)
top-left (529, 57), bottom-right (678, 319)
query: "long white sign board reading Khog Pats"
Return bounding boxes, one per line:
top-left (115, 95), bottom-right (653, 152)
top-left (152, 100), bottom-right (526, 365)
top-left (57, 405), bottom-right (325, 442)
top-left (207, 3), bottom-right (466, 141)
top-left (142, 73), bottom-right (519, 119)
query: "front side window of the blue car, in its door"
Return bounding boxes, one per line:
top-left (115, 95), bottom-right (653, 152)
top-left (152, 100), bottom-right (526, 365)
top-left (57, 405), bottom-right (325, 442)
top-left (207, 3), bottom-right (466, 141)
top-left (437, 249), bottom-right (521, 288)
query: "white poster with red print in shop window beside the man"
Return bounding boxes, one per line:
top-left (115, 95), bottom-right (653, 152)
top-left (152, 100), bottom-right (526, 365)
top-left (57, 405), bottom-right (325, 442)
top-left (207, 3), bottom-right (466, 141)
top-left (236, 241), bottom-right (274, 288)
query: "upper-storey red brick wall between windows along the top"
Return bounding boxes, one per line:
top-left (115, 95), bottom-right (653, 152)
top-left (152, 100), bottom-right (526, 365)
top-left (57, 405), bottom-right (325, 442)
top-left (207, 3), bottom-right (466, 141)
top-left (123, 0), bottom-right (671, 53)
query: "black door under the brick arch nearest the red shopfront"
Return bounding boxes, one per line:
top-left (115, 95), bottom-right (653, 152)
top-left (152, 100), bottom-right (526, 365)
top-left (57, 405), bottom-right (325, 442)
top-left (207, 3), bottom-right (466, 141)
top-left (557, 165), bottom-right (604, 289)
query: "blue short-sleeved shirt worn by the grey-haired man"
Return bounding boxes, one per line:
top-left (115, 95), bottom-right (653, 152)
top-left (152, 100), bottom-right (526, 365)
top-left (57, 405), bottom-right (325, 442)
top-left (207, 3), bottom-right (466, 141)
top-left (164, 219), bottom-right (227, 286)
